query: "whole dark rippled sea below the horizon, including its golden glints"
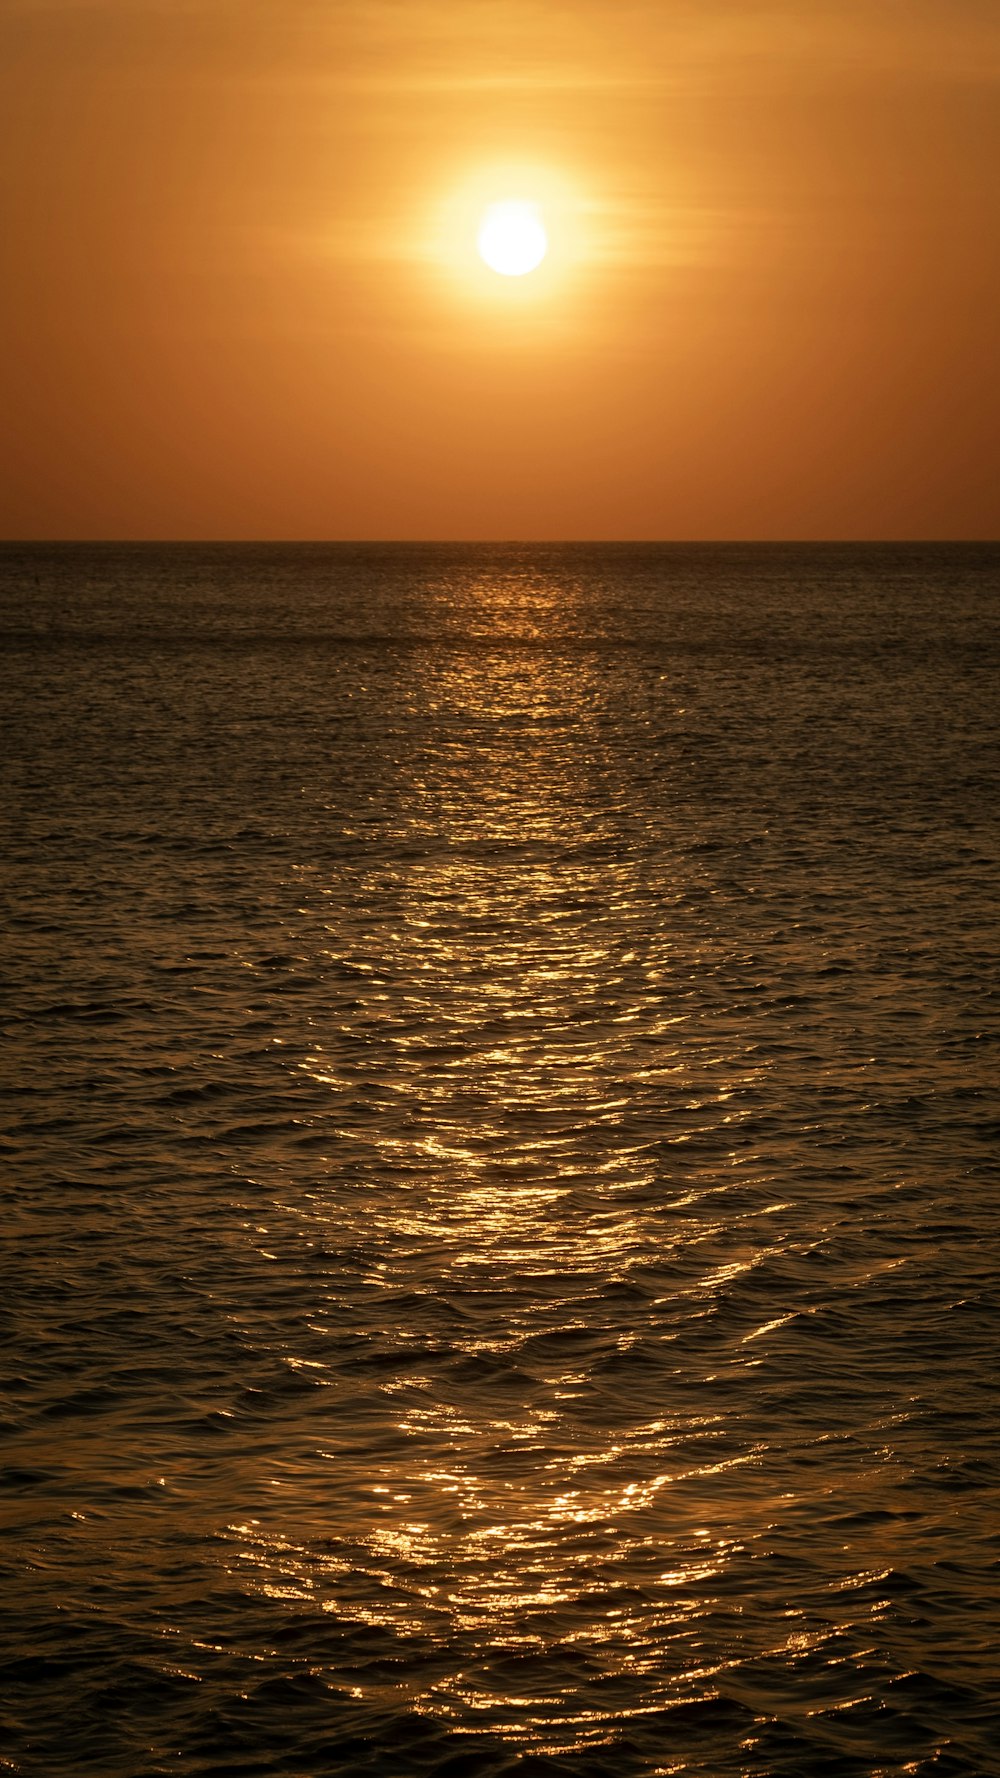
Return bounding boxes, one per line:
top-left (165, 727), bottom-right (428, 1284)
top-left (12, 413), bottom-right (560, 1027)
top-left (0, 546), bottom-right (1000, 1778)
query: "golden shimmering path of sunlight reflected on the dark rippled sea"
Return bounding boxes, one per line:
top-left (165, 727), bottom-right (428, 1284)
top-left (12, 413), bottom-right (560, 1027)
top-left (208, 558), bottom-right (939, 1773)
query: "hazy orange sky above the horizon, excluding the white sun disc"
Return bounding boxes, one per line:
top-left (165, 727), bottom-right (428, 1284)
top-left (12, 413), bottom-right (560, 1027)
top-left (0, 0), bottom-right (1000, 539)
